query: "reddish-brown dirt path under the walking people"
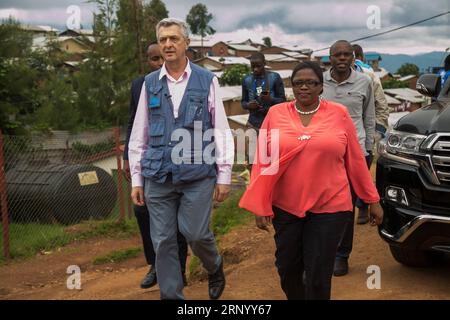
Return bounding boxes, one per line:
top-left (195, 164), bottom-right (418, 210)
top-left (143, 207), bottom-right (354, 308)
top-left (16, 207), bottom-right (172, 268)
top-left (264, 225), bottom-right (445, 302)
top-left (0, 216), bottom-right (450, 300)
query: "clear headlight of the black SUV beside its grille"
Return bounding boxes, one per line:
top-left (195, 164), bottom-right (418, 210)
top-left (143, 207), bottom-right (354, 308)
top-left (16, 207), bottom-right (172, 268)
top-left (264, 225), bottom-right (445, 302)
top-left (378, 129), bottom-right (427, 167)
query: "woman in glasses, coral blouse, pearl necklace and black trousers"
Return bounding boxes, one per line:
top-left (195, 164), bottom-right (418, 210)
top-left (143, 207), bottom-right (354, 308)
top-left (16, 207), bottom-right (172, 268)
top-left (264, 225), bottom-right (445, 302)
top-left (239, 61), bottom-right (383, 299)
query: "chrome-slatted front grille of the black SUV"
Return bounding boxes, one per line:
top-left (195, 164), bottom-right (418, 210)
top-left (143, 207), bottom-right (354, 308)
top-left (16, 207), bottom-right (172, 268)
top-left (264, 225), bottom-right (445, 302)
top-left (431, 136), bottom-right (450, 186)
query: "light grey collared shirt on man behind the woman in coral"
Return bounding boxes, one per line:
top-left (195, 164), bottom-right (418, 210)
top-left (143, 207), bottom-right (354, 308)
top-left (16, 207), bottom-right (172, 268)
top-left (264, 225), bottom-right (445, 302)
top-left (322, 69), bottom-right (375, 155)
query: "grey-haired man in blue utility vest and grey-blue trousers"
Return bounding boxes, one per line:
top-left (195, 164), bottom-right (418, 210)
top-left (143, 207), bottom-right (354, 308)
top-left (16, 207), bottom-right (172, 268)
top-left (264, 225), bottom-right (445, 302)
top-left (128, 18), bottom-right (234, 299)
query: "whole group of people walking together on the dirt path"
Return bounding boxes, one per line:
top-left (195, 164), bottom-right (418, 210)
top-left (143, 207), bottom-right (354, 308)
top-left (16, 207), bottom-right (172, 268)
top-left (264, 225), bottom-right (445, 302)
top-left (124, 18), bottom-right (389, 299)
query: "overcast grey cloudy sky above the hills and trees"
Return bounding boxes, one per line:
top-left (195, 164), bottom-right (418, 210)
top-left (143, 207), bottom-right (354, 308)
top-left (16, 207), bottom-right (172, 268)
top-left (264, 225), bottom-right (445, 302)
top-left (0, 0), bottom-right (450, 55)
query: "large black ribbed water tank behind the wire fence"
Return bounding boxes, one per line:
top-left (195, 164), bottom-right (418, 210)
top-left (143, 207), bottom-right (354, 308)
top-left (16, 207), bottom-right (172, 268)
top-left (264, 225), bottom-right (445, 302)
top-left (6, 164), bottom-right (117, 224)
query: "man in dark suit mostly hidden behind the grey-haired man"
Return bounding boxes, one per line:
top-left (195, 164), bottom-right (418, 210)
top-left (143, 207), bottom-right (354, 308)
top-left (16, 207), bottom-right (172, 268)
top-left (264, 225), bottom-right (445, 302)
top-left (123, 44), bottom-right (187, 289)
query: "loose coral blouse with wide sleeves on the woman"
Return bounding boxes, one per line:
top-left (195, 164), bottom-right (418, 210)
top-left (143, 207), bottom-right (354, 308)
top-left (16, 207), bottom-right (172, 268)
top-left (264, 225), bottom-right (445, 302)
top-left (239, 100), bottom-right (380, 217)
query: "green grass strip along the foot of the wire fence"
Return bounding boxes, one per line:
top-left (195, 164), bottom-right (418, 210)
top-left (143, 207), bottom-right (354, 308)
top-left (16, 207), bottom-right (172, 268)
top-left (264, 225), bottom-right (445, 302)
top-left (0, 219), bottom-right (139, 263)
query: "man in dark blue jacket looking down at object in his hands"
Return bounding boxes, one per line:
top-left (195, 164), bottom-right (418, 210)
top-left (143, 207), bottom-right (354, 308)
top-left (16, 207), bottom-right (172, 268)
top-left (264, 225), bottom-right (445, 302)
top-left (241, 52), bottom-right (286, 129)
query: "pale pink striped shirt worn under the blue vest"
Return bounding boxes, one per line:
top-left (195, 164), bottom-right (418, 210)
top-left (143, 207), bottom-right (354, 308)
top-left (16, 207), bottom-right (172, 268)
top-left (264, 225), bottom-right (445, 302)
top-left (128, 61), bottom-right (234, 187)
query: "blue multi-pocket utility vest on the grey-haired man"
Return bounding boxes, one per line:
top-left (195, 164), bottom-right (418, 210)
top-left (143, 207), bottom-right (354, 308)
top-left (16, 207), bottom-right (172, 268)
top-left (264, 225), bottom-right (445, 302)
top-left (141, 62), bottom-right (216, 184)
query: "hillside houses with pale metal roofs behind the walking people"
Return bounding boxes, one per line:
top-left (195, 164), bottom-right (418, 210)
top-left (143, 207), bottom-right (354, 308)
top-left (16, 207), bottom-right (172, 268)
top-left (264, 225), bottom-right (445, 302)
top-left (14, 26), bottom-right (430, 120)
